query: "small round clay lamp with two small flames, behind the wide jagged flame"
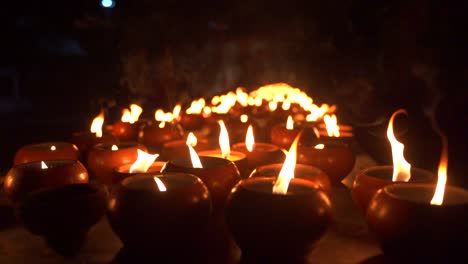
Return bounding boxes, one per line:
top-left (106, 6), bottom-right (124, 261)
top-left (139, 105), bottom-right (182, 152)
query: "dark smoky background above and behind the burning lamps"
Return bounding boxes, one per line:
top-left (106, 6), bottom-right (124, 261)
top-left (0, 0), bottom-right (468, 186)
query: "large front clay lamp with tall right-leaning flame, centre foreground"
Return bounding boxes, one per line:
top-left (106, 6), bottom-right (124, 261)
top-left (226, 132), bottom-right (332, 263)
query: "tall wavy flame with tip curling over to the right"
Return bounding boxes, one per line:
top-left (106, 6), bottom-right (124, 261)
top-left (387, 109), bottom-right (411, 182)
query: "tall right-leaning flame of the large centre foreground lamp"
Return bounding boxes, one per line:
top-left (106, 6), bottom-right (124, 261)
top-left (273, 131), bottom-right (302, 194)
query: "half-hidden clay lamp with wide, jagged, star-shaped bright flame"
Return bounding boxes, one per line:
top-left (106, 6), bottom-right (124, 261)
top-left (114, 149), bottom-right (166, 182)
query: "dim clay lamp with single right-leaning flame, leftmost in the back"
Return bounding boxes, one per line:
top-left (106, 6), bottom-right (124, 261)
top-left (71, 111), bottom-right (118, 161)
